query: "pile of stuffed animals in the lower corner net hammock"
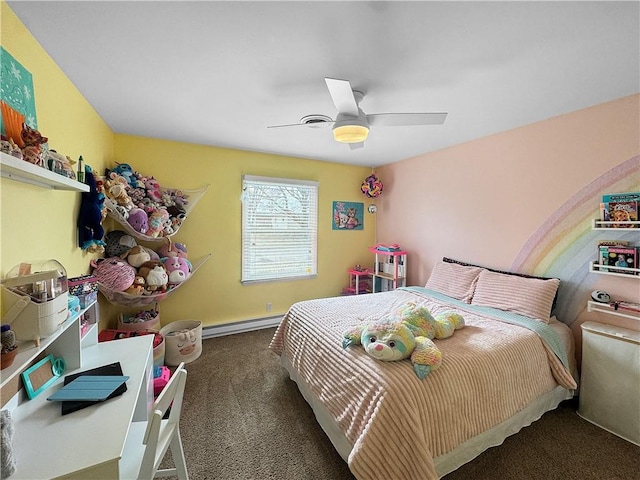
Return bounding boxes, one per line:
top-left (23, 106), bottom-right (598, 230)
top-left (91, 230), bottom-right (193, 296)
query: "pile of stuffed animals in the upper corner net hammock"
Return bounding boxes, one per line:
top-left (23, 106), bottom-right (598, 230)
top-left (104, 163), bottom-right (189, 238)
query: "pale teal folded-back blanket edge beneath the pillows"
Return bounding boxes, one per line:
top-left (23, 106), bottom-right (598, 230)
top-left (398, 287), bottom-right (569, 369)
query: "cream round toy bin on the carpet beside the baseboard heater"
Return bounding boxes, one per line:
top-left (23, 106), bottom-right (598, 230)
top-left (160, 320), bottom-right (202, 367)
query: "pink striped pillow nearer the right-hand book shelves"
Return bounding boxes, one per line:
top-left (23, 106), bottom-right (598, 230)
top-left (471, 270), bottom-right (560, 323)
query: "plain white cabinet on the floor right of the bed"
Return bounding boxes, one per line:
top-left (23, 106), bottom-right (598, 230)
top-left (578, 322), bottom-right (640, 445)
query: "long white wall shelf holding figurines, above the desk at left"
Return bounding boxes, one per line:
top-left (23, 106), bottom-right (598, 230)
top-left (0, 152), bottom-right (89, 192)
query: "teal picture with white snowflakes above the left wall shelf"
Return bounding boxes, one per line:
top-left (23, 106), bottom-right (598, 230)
top-left (0, 47), bottom-right (38, 135)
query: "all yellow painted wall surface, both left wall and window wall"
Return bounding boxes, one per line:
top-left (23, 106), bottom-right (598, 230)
top-left (0, 2), bottom-right (375, 326)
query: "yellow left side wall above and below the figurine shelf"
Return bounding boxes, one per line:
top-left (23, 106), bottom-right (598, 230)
top-left (0, 2), bottom-right (113, 296)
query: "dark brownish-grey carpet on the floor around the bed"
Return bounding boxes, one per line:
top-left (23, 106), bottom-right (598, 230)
top-left (168, 328), bottom-right (640, 480)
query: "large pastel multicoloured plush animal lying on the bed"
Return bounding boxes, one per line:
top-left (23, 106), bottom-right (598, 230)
top-left (342, 303), bottom-right (464, 379)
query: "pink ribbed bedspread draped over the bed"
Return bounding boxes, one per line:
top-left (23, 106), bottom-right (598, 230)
top-left (270, 290), bottom-right (576, 480)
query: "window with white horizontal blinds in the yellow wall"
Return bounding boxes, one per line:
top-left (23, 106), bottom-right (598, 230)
top-left (241, 175), bottom-right (318, 283)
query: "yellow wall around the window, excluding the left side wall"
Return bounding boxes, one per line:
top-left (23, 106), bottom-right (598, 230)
top-left (115, 135), bottom-right (375, 325)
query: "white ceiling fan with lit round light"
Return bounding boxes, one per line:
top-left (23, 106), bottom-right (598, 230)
top-left (267, 77), bottom-right (447, 150)
